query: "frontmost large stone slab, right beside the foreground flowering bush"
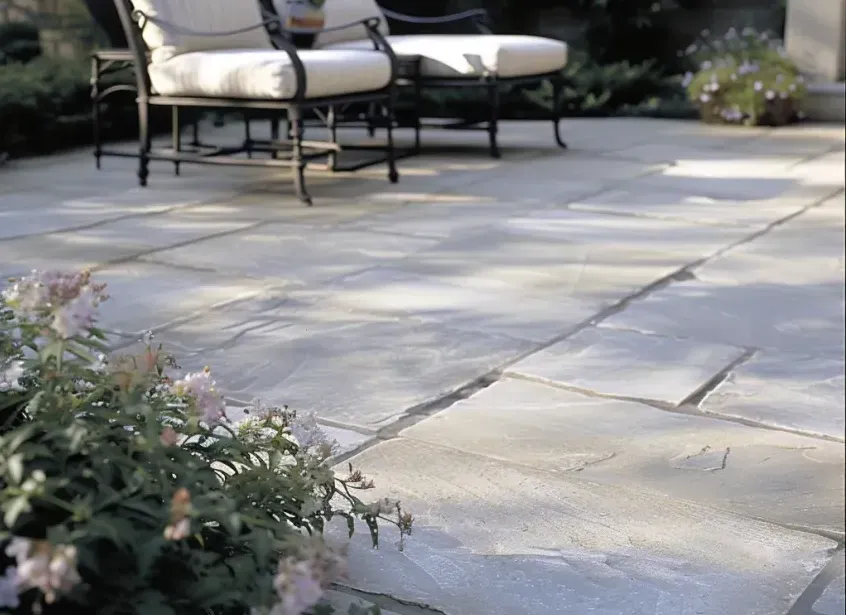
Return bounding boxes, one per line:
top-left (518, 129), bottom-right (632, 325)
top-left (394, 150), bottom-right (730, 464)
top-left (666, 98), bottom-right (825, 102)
top-left (332, 438), bottom-right (835, 615)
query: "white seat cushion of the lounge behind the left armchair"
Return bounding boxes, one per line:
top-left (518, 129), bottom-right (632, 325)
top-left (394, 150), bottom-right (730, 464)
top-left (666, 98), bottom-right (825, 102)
top-left (327, 34), bottom-right (567, 79)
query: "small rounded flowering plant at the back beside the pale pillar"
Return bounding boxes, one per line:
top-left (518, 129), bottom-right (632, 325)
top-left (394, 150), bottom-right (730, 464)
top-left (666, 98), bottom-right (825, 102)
top-left (682, 28), bottom-right (805, 126)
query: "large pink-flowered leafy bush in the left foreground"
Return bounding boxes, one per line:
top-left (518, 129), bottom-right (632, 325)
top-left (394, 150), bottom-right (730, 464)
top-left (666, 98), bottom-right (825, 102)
top-left (0, 272), bottom-right (412, 615)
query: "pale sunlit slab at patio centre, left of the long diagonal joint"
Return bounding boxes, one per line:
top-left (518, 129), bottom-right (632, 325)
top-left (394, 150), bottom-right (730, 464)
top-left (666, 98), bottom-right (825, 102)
top-left (316, 267), bottom-right (602, 342)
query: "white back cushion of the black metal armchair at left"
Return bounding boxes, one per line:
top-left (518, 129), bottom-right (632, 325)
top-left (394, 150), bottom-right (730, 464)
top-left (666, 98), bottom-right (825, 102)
top-left (132, 0), bottom-right (272, 64)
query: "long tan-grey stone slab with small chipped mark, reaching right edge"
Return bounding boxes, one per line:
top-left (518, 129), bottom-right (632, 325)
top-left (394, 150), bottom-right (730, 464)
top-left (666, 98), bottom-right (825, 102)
top-left (401, 379), bottom-right (844, 533)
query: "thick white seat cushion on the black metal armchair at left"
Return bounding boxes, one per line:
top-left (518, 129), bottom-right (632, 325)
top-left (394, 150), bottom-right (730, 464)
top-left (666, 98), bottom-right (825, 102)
top-left (149, 49), bottom-right (391, 100)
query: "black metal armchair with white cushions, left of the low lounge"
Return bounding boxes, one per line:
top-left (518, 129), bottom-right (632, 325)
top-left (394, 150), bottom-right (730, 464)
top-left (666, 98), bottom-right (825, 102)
top-left (108, 0), bottom-right (399, 204)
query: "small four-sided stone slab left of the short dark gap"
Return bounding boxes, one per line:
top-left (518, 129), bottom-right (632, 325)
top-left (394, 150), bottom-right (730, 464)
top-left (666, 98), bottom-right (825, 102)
top-left (507, 328), bottom-right (743, 406)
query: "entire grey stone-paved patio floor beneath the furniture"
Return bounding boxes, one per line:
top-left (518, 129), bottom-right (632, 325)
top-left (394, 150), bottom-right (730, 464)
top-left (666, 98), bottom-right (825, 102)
top-left (0, 120), bottom-right (846, 615)
